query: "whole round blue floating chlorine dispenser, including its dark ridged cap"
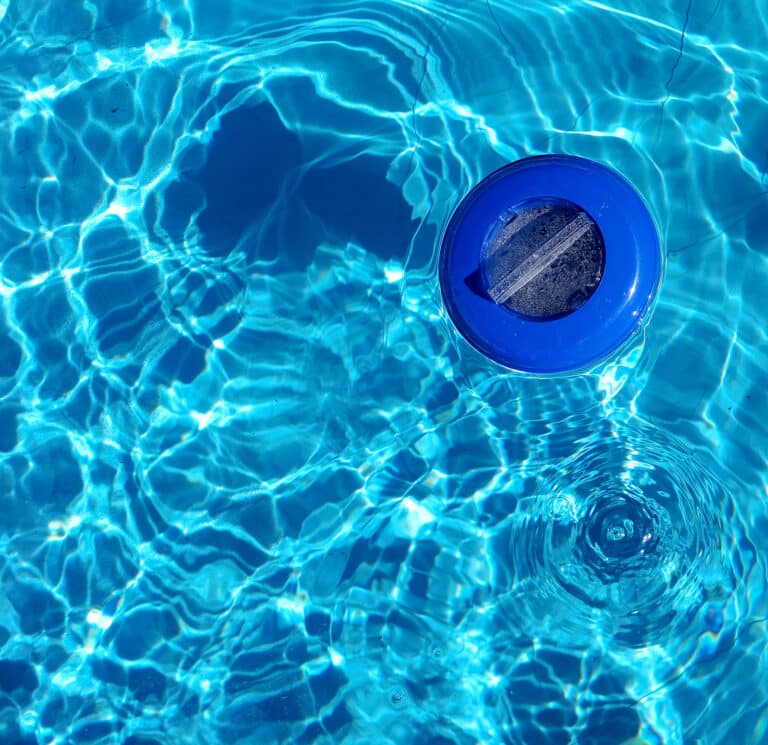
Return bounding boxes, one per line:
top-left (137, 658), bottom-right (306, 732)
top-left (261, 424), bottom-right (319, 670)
top-left (440, 155), bottom-right (662, 373)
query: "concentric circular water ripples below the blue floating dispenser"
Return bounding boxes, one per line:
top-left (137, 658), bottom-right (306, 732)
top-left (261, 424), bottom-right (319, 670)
top-left (504, 428), bottom-right (754, 649)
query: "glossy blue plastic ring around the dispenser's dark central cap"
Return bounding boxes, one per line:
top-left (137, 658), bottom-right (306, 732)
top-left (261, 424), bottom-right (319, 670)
top-left (439, 155), bottom-right (663, 374)
